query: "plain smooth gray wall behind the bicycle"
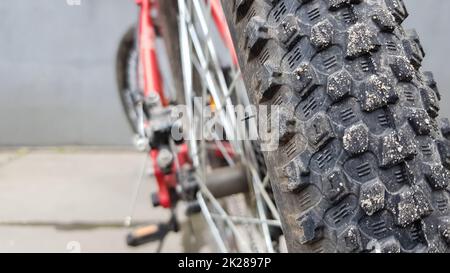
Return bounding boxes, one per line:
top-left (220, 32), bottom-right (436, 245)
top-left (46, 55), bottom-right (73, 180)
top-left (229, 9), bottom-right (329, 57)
top-left (0, 0), bottom-right (450, 145)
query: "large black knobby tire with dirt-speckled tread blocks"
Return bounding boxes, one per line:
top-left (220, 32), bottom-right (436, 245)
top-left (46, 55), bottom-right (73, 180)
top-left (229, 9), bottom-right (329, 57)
top-left (222, 0), bottom-right (450, 252)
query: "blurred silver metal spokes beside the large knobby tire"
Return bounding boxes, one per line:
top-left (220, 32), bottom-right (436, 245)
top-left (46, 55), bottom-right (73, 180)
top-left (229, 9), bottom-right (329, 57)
top-left (178, 0), bottom-right (280, 252)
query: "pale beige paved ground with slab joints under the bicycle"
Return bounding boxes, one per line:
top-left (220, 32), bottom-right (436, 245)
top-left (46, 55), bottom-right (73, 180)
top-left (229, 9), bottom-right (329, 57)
top-left (0, 149), bottom-right (209, 252)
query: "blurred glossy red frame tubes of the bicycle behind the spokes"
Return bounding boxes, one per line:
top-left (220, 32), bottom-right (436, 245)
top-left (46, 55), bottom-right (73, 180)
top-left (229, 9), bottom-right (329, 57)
top-left (135, 0), bottom-right (238, 208)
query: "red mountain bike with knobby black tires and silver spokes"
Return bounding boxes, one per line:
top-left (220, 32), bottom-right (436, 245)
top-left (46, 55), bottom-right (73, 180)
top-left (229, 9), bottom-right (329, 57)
top-left (117, 0), bottom-right (450, 252)
